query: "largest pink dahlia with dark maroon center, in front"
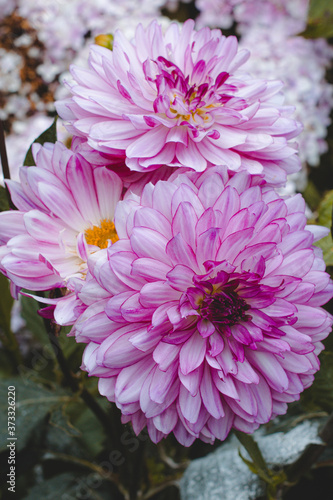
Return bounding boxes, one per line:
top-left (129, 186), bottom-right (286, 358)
top-left (60, 167), bottom-right (333, 446)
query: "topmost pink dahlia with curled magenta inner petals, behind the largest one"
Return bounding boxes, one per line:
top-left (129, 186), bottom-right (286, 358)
top-left (57, 20), bottom-right (300, 188)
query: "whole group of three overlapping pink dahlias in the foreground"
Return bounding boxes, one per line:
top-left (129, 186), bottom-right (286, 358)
top-left (0, 21), bottom-right (333, 446)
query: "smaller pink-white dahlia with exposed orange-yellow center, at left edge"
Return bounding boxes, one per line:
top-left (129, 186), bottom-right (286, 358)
top-left (0, 142), bottom-right (122, 290)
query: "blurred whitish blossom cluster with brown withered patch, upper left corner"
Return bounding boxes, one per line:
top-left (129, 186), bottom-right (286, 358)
top-left (0, 0), bottom-right (170, 135)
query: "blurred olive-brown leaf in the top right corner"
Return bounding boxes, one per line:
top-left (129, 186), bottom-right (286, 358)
top-left (300, 0), bottom-right (333, 38)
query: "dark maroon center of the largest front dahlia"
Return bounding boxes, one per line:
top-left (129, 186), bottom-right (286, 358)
top-left (200, 290), bottom-right (250, 330)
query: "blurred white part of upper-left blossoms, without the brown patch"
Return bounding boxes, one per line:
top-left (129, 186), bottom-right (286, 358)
top-left (18, 0), bottom-right (169, 81)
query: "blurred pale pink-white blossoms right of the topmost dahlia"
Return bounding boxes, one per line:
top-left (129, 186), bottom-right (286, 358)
top-left (196, 0), bottom-right (333, 176)
